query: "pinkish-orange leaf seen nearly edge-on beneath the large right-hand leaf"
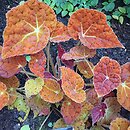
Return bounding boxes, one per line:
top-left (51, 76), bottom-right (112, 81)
top-left (62, 45), bottom-right (96, 60)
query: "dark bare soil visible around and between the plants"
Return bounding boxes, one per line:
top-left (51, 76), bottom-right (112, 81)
top-left (0, 0), bottom-right (130, 130)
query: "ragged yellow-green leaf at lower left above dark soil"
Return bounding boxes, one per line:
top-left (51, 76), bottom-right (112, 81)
top-left (8, 94), bottom-right (30, 122)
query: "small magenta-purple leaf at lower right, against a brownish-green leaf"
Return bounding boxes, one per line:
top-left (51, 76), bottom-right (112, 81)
top-left (92, 103), bottom-right (107, 125)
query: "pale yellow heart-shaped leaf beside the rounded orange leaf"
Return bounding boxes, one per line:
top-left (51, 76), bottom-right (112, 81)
top-left (25, 78), bottom-right (44, 98)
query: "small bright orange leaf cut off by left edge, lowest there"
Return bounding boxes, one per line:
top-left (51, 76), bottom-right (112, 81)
top-left (0, 82), bottom-right (9, 110)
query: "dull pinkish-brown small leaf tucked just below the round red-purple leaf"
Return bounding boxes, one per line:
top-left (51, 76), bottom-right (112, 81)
top-left (86, 89), bottom-right (100, 106)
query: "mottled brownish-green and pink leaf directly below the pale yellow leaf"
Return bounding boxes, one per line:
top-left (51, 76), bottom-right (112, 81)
top-left (26, 95), bottom-right (50, 118)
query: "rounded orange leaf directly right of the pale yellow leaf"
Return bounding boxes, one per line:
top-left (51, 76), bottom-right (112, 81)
top-left (40, 78), bottom-right (63, 103)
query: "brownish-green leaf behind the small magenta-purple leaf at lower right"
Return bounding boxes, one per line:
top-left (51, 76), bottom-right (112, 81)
top-left (101, 97), bottom-right (121, 125)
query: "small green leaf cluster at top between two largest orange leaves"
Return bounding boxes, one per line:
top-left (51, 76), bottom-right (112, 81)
top-left (43, 0), bottom-right (99, 17)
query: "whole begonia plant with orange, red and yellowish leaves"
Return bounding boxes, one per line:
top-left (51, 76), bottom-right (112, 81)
top-left (0, 0), bottom-right (130, 130)
